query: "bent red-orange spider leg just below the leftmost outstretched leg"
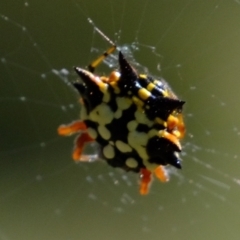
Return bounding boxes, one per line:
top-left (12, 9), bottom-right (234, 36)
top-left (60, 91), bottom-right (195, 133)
top-left (72, 132), bottom-right (94, 161)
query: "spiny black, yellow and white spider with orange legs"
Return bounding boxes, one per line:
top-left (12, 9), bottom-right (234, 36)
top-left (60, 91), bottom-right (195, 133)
top-left (58, 26), bottom-right (185, 195)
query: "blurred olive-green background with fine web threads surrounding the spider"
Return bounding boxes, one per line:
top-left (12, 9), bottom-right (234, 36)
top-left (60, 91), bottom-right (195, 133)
top-left (0, 0), bottom-right (240, 240)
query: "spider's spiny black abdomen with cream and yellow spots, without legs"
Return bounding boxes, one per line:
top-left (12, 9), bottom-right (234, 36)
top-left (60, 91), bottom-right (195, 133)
top-left (74, 53), bottom-right (184, 172)
